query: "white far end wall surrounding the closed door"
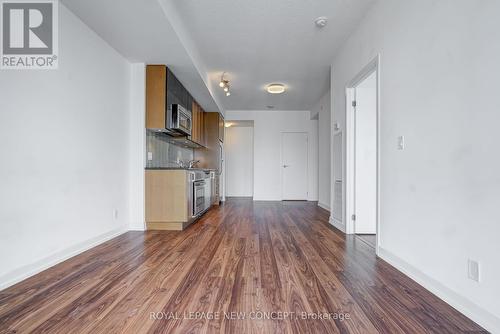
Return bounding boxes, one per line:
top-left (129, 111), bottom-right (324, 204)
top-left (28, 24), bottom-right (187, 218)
top-left (226, 110), bottom-right (318, 201)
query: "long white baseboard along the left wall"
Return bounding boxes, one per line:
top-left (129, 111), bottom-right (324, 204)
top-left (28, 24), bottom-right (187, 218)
top-left (0, 227), bottom-right (128, 290)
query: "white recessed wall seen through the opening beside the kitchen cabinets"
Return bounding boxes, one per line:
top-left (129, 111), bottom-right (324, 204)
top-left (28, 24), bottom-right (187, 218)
top-left (224, 126), bottom-right (253, 197)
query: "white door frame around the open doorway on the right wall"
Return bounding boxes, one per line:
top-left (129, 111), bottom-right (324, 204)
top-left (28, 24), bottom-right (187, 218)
top-left (343, 54), bottom-right (380, 255)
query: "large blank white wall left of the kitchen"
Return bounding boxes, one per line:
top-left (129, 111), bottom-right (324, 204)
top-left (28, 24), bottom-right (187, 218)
top-left (0, 4), bottom-right (130, 288)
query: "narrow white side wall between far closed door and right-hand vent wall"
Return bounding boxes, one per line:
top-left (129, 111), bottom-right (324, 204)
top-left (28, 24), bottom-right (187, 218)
top-left (311, 91), bottom-right (332, 210)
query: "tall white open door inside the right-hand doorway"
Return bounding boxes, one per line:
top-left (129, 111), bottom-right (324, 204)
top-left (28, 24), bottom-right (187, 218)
top-left (354, 72), bottom-right (377, 234)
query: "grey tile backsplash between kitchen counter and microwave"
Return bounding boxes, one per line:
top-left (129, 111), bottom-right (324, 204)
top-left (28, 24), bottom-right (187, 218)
top-left (146, 130), bottom-right (194, 168)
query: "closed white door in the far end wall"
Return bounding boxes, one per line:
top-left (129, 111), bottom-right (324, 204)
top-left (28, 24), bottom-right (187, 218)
top-left (281, 132), bottom-right (308, 201)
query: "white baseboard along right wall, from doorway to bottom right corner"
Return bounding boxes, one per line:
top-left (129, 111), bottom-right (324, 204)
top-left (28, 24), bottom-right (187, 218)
top-left (378, 247), bottom-right (500, 333)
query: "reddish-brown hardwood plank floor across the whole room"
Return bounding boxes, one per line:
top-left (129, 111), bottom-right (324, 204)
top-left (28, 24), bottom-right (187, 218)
top-left (0, 200), bottom-right (483, 334)
